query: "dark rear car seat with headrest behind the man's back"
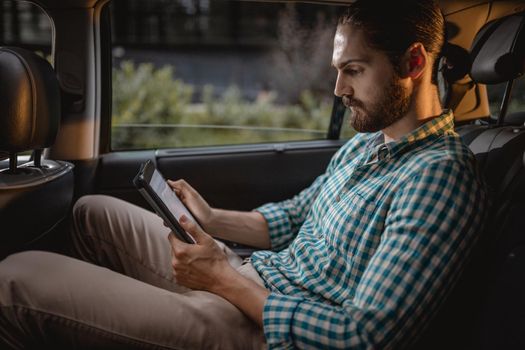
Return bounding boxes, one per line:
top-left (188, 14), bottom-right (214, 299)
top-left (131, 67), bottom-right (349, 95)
top-left (413, 10), bottom-right (525, 349)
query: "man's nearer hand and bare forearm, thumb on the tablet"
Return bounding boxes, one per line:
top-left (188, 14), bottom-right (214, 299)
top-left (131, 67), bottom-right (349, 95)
top-left (168, 216), bottom-right (270, 327)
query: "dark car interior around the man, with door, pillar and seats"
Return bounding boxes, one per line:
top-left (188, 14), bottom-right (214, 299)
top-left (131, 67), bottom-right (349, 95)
top-left (0, 0), bottom-right (525, 349)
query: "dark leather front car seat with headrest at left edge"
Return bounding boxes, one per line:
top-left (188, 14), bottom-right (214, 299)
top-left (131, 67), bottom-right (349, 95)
top-left (0, 47), bottom-right (74, 260)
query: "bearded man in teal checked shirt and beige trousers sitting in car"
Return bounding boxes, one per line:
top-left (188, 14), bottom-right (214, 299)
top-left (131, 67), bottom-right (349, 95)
top-left (0, 0), bottom-right (487, 349)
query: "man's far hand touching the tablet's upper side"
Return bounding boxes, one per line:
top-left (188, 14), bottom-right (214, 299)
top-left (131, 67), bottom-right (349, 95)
top-left (168, 180), bottom-right (213, 232)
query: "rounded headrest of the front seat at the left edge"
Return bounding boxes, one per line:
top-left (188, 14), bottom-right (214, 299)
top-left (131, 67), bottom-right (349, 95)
top-left (0, 47), bottom-right (60, 152)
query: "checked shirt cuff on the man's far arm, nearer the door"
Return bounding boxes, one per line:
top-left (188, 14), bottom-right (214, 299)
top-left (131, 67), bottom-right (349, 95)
top-left (254, 203), bottom-right (293, 251)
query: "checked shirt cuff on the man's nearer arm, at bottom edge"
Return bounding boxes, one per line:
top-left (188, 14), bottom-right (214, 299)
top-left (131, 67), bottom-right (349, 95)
top-left (263, 293), bottom-right (303, 349)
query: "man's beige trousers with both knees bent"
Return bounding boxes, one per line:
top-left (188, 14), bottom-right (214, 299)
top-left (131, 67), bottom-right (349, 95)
top-left (0, 195), bottom-right (265, 349)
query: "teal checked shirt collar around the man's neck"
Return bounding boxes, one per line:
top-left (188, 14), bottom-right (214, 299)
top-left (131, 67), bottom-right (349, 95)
top-left (367, 110), bottom-right (455, 162)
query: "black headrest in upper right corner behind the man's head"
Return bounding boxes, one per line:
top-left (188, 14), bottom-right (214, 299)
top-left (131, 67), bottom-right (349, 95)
top-left (470, 13), bottom-right (525, 84)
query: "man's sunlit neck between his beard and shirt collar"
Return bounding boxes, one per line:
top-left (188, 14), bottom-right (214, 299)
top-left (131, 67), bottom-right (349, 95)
top-left (381, 86), bottom-right (443, 143)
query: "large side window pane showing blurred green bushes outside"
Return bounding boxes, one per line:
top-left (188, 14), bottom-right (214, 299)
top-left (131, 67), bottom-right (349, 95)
top-left (110, 0), bottom-right (339, 149)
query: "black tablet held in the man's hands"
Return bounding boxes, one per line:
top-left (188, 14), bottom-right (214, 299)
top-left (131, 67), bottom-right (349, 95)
top-left (133, 160), bottom-right (199, 244)
